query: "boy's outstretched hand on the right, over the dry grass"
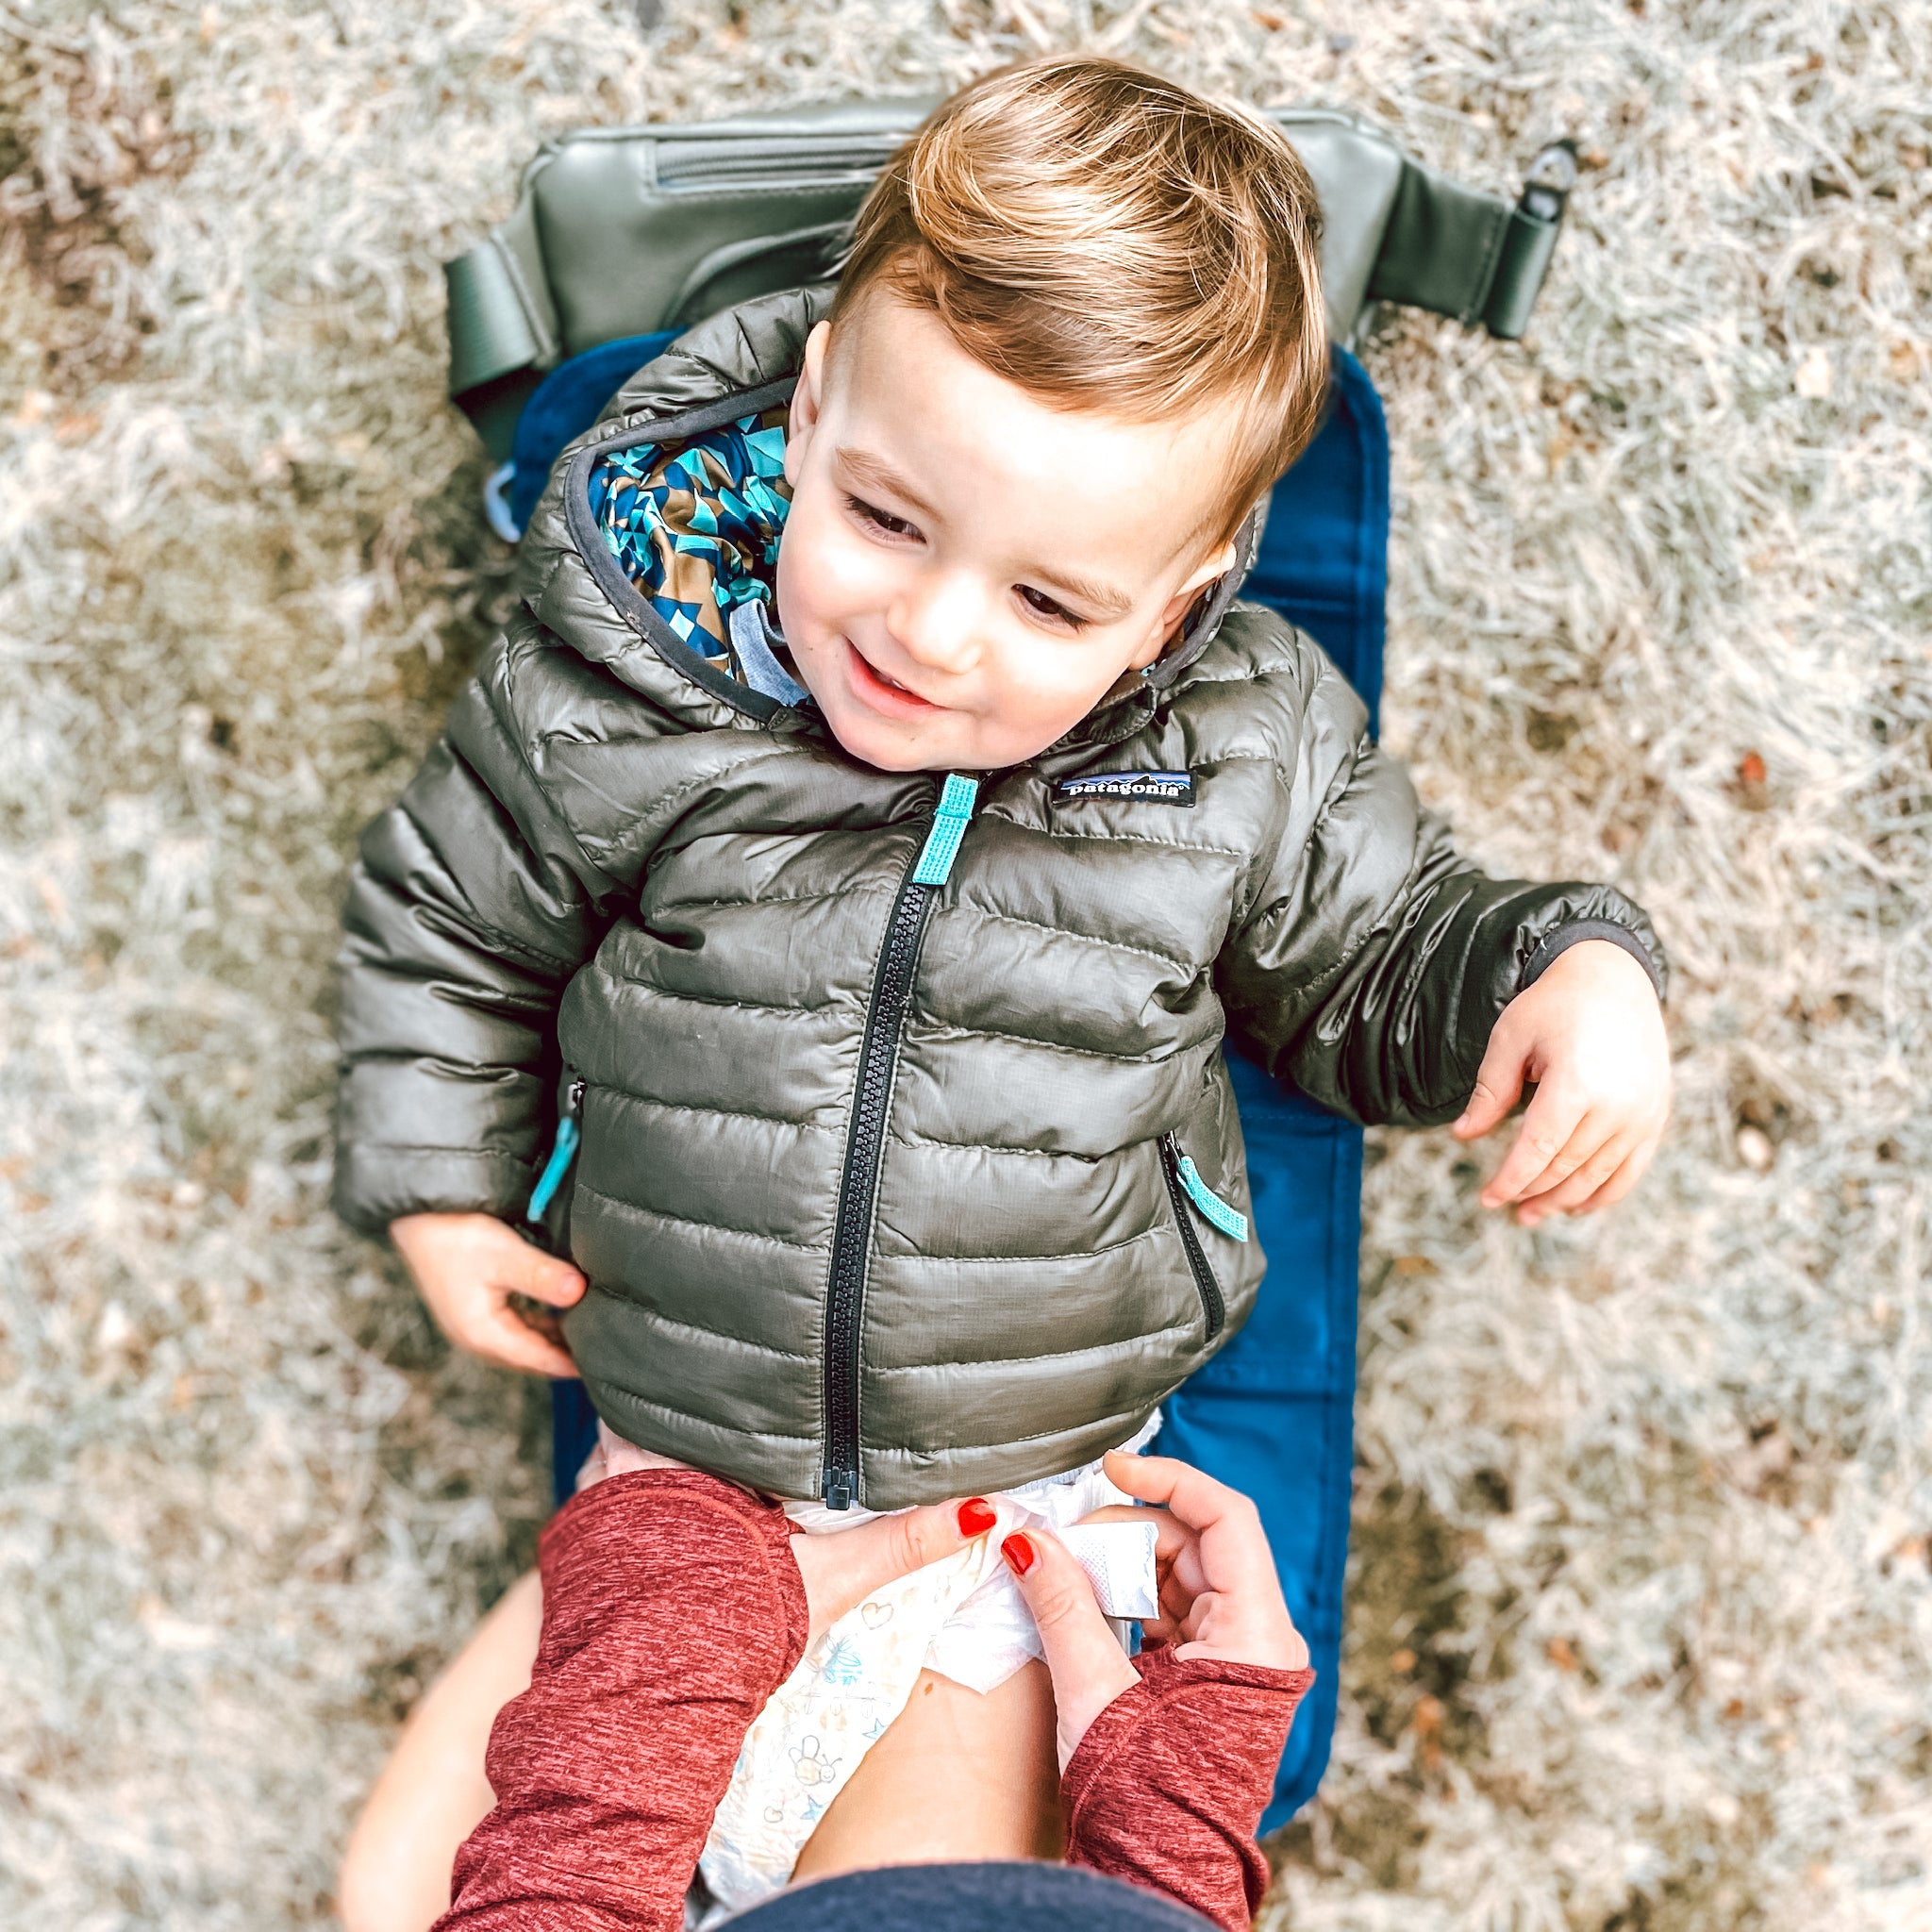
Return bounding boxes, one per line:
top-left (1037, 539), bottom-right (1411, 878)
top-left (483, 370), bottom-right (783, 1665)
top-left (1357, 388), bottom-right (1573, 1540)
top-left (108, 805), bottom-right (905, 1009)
top-left (1451, 939), bottom-right (1672, 1226)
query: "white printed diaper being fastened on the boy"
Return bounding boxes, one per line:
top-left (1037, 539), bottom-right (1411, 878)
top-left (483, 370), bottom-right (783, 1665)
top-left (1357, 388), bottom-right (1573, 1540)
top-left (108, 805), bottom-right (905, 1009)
top-left (593, 1412), bottom-right (1161, 1923)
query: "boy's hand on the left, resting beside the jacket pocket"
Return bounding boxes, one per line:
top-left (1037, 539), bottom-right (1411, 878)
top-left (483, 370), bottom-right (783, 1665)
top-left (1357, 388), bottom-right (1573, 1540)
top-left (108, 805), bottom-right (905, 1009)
top-left (389, 1213), bottom-right (586, 1381)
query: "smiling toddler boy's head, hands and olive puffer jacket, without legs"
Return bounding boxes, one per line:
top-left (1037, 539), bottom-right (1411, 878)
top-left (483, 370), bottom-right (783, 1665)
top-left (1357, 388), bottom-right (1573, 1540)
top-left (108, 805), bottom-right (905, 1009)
top-left (336, 58), bottom-right (1669, 1908)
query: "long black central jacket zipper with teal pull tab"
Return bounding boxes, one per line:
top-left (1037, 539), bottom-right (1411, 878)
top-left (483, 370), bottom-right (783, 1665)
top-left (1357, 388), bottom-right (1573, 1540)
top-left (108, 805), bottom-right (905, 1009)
top-left (823, 773), bottom-right (979, 1508)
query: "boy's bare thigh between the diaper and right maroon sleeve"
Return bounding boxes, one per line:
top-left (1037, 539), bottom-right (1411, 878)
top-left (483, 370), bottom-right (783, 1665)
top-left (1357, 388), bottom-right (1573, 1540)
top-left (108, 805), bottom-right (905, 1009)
top-left (792, 1663), bottom-right (1062, 1880)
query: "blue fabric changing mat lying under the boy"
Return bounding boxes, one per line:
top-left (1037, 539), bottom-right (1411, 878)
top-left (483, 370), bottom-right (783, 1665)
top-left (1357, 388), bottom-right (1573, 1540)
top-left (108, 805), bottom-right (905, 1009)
top-left (533, 336), bottom-right (1390, 1829)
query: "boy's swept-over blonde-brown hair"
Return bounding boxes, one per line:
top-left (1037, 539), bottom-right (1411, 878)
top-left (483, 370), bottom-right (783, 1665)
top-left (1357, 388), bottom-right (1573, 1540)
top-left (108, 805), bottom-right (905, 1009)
top-left (833, 54), bottom-right (1329, 537)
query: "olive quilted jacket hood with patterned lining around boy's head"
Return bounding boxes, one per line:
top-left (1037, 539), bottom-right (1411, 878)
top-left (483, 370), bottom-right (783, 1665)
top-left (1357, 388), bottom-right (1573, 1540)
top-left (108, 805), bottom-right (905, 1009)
top-left (520, 286), bottom-right (1267, 730)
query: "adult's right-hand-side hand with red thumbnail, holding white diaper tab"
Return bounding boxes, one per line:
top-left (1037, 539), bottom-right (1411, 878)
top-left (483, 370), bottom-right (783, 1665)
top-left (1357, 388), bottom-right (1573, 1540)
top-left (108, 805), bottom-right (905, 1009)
top-left (1001, 1451), bottom-right (1307, 1770)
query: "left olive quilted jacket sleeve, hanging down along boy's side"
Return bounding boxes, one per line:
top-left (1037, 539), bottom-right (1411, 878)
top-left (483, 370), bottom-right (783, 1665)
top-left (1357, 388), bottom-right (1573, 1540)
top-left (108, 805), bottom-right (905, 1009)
top-left (334, 643), bottom-right (608, 1235)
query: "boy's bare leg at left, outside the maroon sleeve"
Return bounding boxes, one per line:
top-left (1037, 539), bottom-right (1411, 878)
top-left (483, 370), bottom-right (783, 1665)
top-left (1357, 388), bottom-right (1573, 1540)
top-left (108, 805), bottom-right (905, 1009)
top-left (336, 1571), bottom-right (544, 1932)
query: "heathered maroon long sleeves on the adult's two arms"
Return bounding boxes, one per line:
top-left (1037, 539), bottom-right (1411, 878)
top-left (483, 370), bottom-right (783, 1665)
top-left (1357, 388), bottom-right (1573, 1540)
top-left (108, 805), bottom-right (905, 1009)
top-left (437, 1471), bottom-right (1314, 1932)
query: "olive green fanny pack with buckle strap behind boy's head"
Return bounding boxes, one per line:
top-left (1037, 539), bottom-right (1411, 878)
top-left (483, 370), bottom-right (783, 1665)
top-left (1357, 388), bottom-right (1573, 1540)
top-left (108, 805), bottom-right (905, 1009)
top-left (444, 100), bottom-right (1574, 458)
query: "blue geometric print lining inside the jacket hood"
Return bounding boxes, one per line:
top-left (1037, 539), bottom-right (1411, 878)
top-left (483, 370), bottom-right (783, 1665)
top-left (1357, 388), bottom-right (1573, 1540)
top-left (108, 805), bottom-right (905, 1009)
top-left (591, 409), bottom-right (792, 669)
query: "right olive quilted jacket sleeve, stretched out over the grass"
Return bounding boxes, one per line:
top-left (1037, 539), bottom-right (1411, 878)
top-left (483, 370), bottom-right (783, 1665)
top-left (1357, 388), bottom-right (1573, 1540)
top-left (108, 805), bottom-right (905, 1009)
top-left (1221, 641), bottom-right (1665, 1126)
